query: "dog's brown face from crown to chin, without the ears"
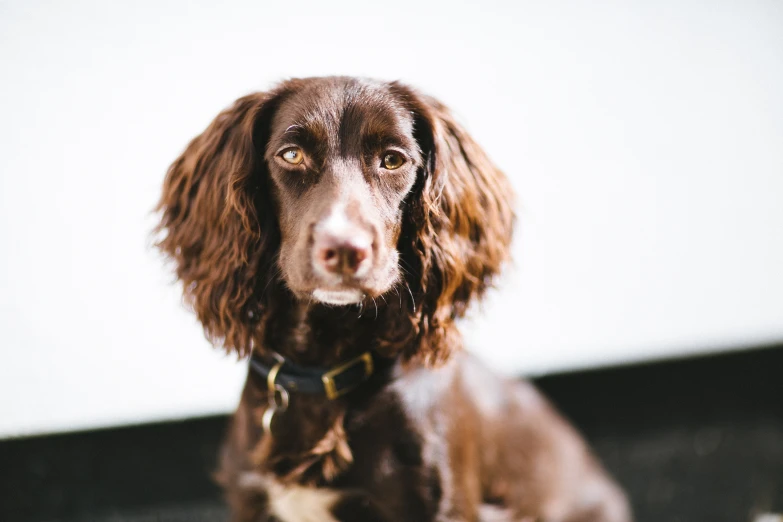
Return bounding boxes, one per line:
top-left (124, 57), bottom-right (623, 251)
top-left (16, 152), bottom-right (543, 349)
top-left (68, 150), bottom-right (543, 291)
top-left (264, 78), bottom-right (422, 305)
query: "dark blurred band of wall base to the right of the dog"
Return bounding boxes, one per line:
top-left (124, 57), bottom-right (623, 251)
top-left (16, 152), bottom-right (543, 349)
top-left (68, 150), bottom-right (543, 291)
top-left (537, 347), bottom-right (783, 522)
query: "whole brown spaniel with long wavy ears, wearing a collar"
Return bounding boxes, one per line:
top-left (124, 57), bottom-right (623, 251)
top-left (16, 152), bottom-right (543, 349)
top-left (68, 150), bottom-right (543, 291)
top-left (159, 77), bottom-right (630, 522)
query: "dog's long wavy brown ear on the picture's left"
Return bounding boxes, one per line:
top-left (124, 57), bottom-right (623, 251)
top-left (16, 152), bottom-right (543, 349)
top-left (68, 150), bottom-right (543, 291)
top-left (156, 89), bottom-right (290, 355)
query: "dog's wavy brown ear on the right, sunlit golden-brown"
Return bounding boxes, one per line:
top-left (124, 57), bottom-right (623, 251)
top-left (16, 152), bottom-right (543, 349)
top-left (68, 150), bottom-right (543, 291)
top-left (391, 83), bottom-right (515, 364)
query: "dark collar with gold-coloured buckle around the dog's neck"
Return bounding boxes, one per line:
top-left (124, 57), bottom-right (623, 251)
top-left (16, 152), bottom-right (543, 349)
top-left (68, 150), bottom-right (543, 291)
top-left (250, 351), bottom-right (377, 400)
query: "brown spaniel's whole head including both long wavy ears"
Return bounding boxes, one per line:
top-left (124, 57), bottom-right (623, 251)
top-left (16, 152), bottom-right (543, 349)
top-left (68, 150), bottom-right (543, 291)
top-left (158, 78), bottom-right (513, 360)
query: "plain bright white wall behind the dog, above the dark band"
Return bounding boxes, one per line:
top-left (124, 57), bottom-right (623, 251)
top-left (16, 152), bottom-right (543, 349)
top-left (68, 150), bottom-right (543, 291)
top-left (0, 0), bottom-right (783, 435)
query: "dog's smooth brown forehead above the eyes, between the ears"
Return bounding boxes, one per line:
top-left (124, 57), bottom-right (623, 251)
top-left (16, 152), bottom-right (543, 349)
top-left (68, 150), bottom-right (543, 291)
top-left (273, 78), bottom-right (413, 140)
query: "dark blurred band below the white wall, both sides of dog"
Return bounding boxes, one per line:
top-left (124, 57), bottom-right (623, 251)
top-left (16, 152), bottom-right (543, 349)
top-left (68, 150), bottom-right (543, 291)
top-left (0, 346), bottom-right (783, 522)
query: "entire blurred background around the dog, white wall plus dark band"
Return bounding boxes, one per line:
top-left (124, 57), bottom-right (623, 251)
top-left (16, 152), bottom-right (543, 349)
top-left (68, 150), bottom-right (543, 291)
top-left (0, 0), bottom-right (783, 522)
